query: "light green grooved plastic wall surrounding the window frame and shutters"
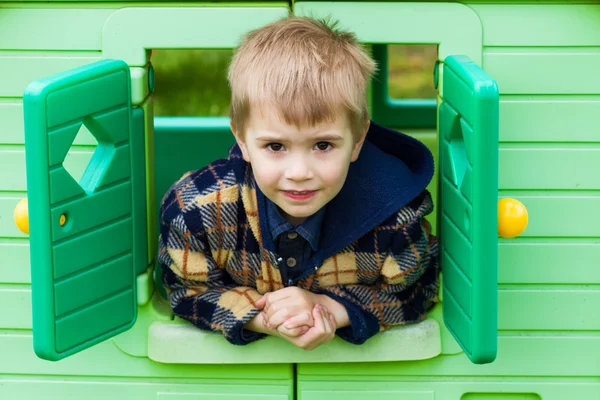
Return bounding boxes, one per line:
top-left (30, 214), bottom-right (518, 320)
top-left (0, 1), bottom-right (600, 400)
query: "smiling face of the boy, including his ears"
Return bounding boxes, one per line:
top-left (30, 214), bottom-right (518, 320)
top-left (232, 113), bottom-right (368, 225)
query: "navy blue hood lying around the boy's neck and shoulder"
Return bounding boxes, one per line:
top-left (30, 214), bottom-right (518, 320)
top-left (230, 122), bottom-right (434, 262)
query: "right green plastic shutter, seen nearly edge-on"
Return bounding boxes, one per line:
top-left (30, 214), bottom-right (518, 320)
top-left (439, 56), bottom-right (499, 364)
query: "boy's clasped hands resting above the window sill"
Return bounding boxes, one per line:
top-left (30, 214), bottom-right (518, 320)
top-left (247, 287), bottom-right (348, 350)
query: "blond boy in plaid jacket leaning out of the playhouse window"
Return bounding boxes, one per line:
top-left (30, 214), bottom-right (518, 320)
top-left (158, 17), bottom-right (439, 350)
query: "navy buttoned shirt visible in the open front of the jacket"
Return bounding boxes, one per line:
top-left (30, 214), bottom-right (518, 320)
top-left (265, 199), bottom-right (326, 286)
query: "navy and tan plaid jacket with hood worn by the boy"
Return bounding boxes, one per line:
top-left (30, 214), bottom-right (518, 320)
top-left (158, 124), bottom-right (439, 345)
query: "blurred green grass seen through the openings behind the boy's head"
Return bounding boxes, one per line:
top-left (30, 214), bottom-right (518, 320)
top-left (152, 45), bottom-right (437, 116)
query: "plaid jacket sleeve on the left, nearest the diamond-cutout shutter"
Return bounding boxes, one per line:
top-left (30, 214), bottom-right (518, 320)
top-left (158, 189), bottom-right (265, 345)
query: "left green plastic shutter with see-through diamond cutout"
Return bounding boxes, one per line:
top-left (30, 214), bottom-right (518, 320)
top-left (23, 60), bottom-right (147, 360)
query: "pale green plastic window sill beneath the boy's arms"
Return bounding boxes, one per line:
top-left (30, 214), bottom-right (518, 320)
top-left (148, 318), bottom-right (442, 364)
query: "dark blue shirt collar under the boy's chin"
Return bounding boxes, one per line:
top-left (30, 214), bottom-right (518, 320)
top-left (265, 199), bottom-right (325, 251)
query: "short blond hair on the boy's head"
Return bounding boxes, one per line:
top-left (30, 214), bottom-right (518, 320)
top-left (228, 16), bottom-right (376, 137)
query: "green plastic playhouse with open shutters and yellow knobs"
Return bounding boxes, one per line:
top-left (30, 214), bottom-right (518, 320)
top-left (0, 0), bottom-right (600, 400)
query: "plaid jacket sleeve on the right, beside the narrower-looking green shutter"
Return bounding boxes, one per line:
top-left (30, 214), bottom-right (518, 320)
top-left (322, 194), bottom-right (439, 344)
